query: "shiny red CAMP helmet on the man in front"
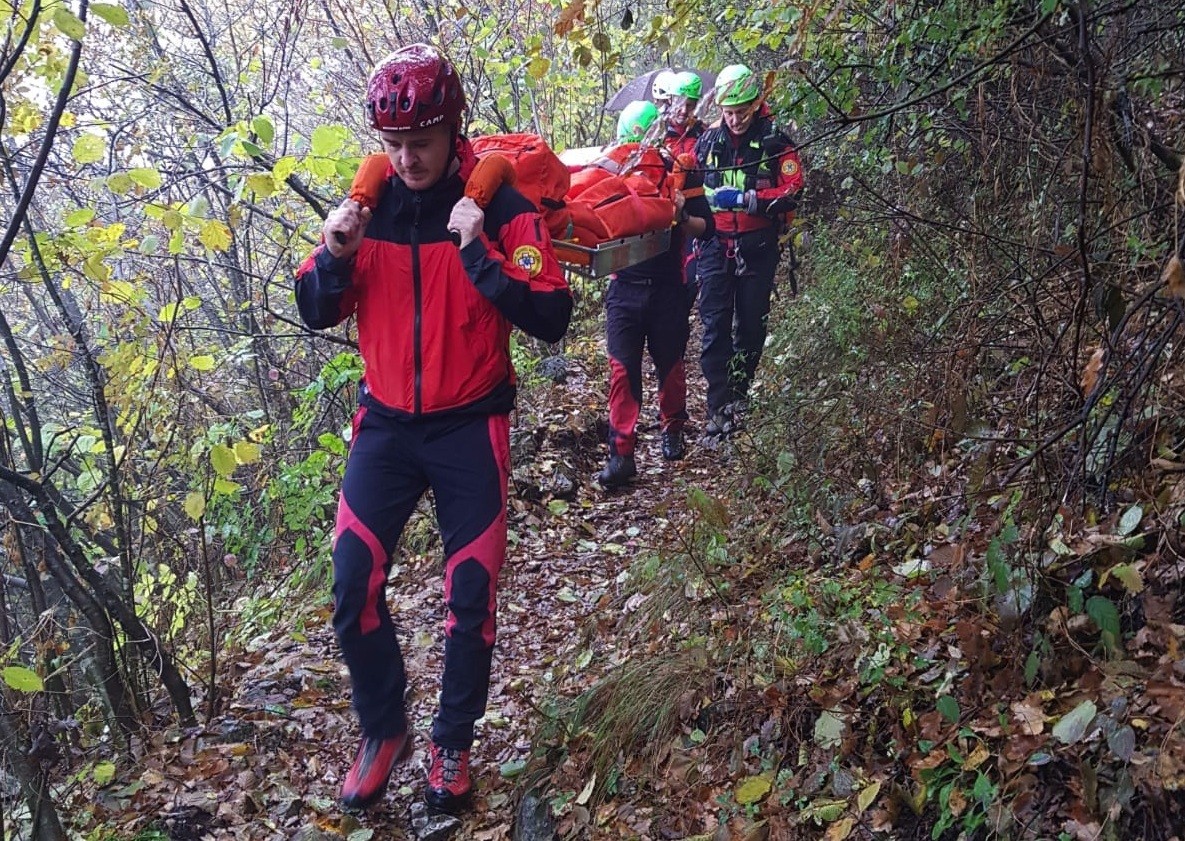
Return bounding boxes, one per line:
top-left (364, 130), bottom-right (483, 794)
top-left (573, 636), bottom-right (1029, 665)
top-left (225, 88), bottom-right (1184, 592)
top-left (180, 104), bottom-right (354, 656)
top-left (366, 44), bottom-right (465, 131)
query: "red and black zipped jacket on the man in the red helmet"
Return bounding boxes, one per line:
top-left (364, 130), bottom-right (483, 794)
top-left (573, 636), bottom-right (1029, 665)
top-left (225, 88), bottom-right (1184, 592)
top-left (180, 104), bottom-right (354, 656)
top-left (296, 140), bottom-right (572, 417)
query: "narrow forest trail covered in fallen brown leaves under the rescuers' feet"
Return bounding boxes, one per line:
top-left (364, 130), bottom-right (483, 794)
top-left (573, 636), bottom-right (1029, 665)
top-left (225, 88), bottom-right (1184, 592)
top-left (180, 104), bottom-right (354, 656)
top-left (128, 300), bottom-right (739, 841)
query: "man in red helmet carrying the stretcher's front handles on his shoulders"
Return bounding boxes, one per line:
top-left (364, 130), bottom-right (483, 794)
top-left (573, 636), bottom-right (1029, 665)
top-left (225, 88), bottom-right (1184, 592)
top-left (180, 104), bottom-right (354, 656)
top-left (296, 44), bottom-right (572, 811)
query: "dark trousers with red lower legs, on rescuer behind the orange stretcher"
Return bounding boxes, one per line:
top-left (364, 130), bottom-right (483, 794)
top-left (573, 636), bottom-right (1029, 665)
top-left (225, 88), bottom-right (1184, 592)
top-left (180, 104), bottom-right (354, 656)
top-left (604, 280), bottom-right (690, 456)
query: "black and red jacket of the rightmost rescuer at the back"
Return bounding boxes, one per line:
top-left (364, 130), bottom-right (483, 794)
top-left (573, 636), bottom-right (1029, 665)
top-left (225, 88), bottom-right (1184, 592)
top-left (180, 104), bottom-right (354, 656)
top-left (696, 105), bottom-right (803, 237)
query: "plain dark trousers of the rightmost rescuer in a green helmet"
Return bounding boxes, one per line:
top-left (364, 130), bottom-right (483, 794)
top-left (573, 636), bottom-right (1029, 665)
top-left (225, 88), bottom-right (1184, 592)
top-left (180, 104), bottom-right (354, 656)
top-left (699, 227), bottom-right (779, 417)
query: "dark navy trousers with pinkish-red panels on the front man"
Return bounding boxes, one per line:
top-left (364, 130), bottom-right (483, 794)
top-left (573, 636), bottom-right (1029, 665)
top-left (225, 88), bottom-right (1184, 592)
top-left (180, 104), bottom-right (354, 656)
top-left (333, 409), bottom-right (510, 750)
